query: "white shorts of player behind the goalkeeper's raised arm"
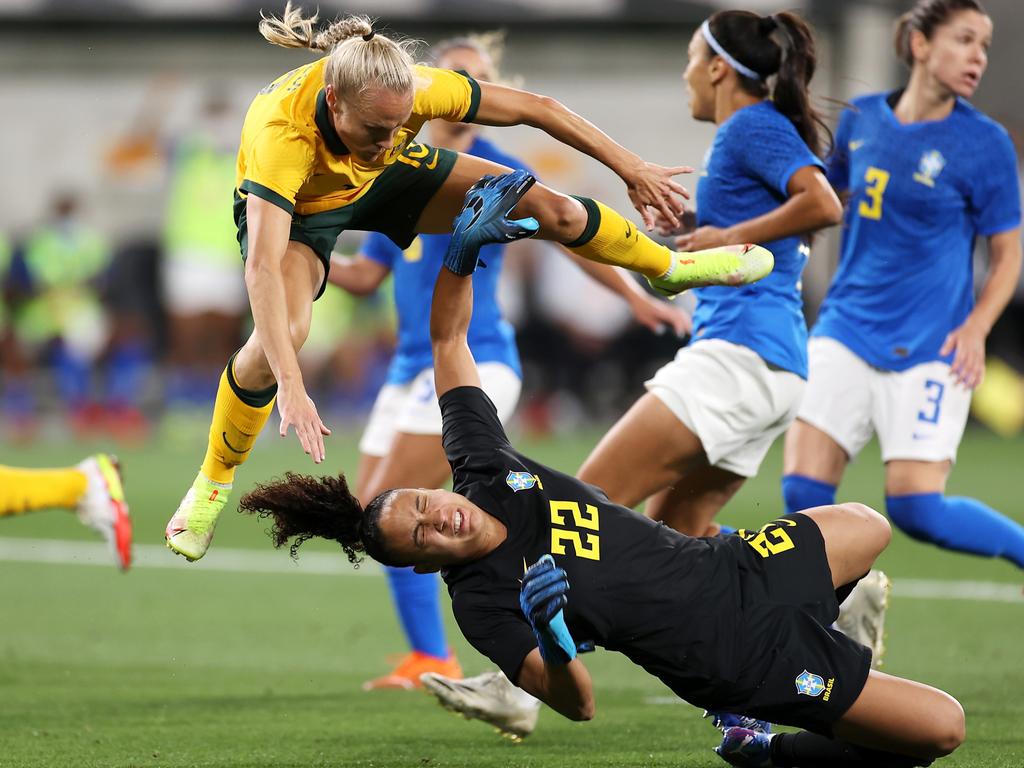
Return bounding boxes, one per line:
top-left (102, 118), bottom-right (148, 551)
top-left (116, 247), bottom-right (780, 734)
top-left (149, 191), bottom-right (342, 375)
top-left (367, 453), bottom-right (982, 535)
top-left (359, 362), bottom-right (522, 456)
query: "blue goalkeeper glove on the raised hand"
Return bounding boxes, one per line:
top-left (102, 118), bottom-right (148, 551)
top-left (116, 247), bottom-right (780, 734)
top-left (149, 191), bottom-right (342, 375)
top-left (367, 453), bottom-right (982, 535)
top-left (444, 171), bottom-right (541, 278)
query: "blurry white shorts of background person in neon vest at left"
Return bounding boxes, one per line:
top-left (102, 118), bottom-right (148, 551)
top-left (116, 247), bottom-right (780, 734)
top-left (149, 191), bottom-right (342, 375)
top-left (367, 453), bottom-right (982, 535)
top-left (161, 255), bottom-right (249, 314)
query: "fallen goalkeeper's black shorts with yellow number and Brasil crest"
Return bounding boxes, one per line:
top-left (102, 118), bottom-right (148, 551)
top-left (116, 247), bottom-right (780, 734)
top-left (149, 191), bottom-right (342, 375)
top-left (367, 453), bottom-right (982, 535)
top-left (716, 513), bottom-right (871, 735)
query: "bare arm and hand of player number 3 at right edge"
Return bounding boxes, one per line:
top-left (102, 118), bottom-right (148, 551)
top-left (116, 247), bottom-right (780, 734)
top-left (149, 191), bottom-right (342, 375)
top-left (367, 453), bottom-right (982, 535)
top-left (941, 227), bottom-right (1021, 388)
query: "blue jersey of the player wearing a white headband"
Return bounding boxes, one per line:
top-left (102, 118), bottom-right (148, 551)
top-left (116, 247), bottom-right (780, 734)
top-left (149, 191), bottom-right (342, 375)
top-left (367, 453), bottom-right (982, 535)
top-left (693, 101), bottom-right (823, 379)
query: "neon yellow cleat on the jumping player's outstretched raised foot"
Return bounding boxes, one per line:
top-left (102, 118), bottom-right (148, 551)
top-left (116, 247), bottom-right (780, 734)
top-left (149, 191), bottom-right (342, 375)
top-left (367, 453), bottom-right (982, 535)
top-left (648, 243), bottom-right (775, 296)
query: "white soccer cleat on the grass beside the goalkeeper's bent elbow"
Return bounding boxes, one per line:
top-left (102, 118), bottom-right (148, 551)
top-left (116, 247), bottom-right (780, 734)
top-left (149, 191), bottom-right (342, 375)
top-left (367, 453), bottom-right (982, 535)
top-left (420, 672), bottom-right (541, 740)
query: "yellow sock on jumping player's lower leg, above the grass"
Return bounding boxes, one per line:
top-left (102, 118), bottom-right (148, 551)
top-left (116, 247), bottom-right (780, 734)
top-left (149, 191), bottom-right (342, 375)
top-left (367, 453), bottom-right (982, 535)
top-left (203, 355), bottom-right (278, 484)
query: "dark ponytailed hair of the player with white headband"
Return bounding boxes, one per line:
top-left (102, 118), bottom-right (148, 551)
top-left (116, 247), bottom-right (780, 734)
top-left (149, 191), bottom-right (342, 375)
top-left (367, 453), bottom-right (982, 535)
top-left (708, 10), bottom-right (831, 157)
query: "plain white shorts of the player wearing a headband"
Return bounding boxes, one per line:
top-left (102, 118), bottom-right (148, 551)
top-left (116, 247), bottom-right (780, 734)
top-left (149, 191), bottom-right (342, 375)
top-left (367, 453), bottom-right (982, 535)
top-left (645, 339), bottom-right (805, 477)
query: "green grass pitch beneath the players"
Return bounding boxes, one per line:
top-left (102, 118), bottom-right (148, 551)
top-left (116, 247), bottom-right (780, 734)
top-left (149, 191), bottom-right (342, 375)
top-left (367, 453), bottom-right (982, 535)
top-left (0, 423), bottom-right (1024, 768)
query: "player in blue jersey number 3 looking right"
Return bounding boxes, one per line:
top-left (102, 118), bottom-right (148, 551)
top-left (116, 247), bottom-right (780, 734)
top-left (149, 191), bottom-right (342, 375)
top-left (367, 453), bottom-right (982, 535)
top-left (782, 0), bottom-right (1024, 567)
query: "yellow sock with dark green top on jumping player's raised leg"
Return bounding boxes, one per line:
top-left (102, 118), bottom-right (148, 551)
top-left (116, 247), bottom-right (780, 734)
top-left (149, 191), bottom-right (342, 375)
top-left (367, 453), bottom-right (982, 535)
top-left (565, 197), bottom-right (672, 278)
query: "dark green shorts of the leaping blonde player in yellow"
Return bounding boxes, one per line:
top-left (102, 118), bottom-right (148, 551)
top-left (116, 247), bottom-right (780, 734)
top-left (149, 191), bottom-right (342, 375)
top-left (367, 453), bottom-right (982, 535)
top-left (233, 142), bottom-right (459, 299)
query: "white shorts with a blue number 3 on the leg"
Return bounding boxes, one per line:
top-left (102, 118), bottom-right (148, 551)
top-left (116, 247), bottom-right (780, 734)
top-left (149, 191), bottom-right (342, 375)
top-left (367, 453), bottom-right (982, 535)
top-left (798, 336), bottom-right (971, 462)
